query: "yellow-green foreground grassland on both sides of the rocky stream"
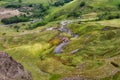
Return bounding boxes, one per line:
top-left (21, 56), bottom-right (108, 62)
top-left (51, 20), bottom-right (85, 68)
top-left (1, 19), bottom-right (120, 80)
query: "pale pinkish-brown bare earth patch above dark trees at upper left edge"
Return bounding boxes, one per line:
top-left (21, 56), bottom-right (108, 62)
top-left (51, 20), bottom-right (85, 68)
top-left (0, 8), bottom-right (20, 19)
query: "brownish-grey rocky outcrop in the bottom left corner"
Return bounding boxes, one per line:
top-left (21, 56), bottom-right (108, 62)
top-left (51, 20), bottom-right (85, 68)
top-left (0, 52), bottom-right (33, 80)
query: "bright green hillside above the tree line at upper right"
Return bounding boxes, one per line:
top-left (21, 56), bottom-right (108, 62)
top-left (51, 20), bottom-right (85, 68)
top-left (45, 0), bottom-right (120, 19)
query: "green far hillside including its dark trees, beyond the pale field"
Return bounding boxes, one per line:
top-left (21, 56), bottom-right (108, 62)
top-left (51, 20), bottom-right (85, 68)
top-left (31, 0), bottom-right (120, 26)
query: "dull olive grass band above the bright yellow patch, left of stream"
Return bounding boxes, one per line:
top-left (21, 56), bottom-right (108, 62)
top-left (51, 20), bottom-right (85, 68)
top-left (0, 31), bottom-right (57, 48)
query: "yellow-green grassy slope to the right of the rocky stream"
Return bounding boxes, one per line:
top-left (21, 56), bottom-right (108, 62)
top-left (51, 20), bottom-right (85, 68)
top-left (57, 20), bottom-right (120, 80)
